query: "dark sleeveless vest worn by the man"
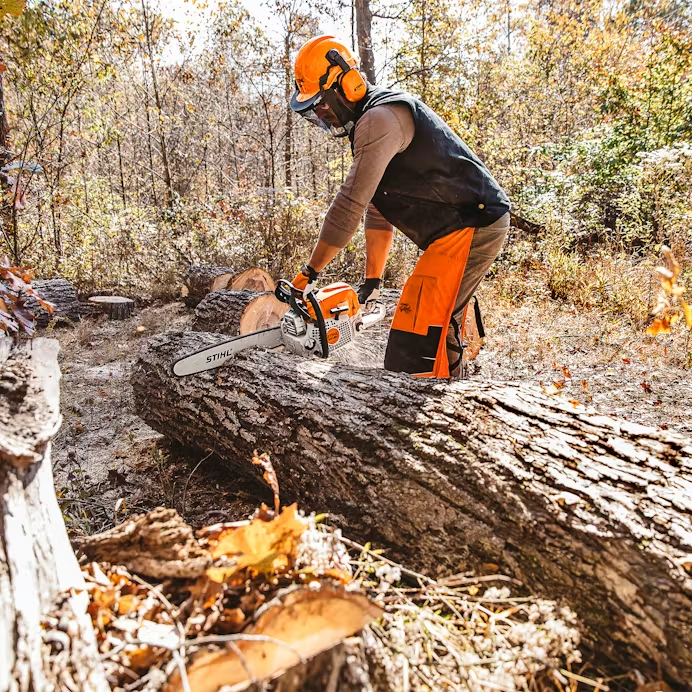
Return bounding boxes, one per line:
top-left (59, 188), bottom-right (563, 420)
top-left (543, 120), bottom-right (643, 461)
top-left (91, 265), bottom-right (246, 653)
top-left (350, 86), bottom-right (510, 250)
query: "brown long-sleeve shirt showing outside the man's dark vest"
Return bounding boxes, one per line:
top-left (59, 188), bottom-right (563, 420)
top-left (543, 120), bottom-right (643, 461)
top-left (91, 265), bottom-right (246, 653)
top-left (320, 103), bottom-right (415, 247)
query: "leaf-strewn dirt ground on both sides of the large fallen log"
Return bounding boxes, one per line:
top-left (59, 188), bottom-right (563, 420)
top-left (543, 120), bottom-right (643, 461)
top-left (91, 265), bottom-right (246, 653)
top-left (51, 283), bottom-right (692, 534)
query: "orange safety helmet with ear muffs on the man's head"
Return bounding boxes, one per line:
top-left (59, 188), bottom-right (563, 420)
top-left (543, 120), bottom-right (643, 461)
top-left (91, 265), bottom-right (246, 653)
top-left (291, 36), bottom-right (367, 114)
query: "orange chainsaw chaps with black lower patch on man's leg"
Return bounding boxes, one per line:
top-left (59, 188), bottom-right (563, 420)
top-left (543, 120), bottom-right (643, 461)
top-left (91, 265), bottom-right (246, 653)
top-left (384, 228), bottom-right (474, 379)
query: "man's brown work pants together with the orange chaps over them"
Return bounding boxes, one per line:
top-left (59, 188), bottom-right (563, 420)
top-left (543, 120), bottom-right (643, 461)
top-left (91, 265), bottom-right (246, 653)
top-left (384, 214), bottom-right (509, 379)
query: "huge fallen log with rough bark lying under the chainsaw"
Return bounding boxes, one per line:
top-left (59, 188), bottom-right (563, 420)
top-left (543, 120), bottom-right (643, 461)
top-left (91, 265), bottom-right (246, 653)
top-left (132, 332), bottom-right (692, 684)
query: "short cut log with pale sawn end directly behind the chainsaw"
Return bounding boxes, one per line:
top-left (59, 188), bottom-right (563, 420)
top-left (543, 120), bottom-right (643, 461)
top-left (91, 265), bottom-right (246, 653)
top-left (193, 291), bottom-right (289, 336)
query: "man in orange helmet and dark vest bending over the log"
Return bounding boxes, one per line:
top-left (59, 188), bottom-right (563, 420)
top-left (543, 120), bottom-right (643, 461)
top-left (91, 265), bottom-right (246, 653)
top-left (291, 36), bottom-right (509, 378)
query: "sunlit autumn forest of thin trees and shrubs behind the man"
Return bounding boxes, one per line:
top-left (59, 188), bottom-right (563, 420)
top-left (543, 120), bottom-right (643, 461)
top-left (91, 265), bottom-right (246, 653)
top-left (0, 0), bottom-right (692, 332)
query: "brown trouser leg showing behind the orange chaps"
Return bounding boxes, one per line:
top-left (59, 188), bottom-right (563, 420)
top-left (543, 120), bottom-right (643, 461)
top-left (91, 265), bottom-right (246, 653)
top-left (447, 214), bottom-right (509, 377)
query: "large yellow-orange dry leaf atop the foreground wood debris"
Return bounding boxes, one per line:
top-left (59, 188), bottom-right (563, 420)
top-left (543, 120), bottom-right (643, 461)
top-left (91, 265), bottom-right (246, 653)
top-left (207, 504), bottom-right (308, 583)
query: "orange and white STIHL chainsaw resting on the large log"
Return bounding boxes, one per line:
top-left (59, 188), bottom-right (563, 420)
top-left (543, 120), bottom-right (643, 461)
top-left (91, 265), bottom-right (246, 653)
top-left (173, 279), bottom-right (386, 377)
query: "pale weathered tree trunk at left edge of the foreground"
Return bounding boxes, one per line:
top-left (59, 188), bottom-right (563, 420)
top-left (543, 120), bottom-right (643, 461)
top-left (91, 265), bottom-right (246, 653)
top-left (0, 339), bottom-right (110, 692)
